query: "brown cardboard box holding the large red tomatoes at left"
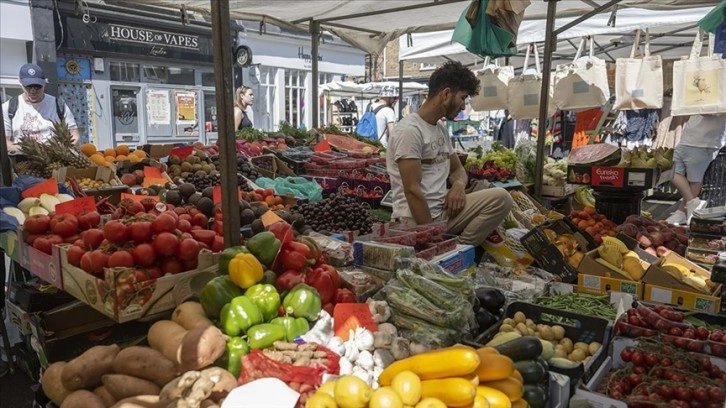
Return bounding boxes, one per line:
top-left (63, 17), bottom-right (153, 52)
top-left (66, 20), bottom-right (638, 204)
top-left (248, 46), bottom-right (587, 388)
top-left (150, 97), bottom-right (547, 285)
top-left (59, 245), bottom-right (219, 323)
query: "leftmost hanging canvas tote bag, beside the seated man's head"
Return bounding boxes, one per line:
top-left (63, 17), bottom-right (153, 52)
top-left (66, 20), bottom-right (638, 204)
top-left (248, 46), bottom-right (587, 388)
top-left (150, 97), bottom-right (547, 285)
top-left (471, 57), bottom-right (514, 112)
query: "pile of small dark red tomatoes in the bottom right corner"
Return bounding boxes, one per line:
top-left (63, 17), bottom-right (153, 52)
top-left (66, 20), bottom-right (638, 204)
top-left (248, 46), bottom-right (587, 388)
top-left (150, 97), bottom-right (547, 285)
top-left (600, 339), bottom-right (726, 408)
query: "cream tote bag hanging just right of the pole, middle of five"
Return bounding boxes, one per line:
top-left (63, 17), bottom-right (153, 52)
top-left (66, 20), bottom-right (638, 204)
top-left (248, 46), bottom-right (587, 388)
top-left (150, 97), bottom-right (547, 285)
top-left (554, 36), bottom-right (610, 112)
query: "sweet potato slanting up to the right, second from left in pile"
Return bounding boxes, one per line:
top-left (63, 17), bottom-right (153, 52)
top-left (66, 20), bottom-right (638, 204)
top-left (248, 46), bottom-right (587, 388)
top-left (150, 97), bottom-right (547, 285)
top-left (61, 344), bottom-right (119, 391)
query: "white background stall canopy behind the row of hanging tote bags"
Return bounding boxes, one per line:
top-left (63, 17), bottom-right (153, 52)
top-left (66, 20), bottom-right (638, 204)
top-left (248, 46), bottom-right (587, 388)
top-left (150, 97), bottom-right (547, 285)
top-left (398, 7), bottom-right (712, 67)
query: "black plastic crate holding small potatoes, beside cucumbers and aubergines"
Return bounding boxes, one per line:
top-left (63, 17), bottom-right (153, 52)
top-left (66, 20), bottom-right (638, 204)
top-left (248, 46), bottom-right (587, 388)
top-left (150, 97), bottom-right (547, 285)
top-left (475, 302), bottom-right (610, 392)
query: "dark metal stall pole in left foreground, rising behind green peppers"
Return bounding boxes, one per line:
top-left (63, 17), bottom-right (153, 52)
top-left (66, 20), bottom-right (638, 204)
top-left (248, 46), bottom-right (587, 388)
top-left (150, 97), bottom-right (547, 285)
top-left (210, 0), bottom-right (242, 247)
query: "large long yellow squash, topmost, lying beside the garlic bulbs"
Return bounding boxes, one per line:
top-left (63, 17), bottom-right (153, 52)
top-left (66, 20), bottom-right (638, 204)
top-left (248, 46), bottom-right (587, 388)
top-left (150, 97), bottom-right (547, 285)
top-left (378, 346), bottom-right (484, 386)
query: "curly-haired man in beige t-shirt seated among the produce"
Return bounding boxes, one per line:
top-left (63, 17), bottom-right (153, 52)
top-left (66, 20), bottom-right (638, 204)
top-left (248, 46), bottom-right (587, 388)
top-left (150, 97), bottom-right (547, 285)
top-left (386, 62), bottom-right (512, 258)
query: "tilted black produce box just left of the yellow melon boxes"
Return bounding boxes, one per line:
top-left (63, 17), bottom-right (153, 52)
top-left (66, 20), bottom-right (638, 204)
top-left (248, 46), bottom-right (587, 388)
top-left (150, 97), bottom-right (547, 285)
top-left (520, 219), bottom-right (596, 282)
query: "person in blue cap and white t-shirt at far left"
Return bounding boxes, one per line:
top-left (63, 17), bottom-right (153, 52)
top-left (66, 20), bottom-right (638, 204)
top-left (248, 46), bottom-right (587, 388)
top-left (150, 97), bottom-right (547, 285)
top-left (2, 64), bottom-right (80, 151)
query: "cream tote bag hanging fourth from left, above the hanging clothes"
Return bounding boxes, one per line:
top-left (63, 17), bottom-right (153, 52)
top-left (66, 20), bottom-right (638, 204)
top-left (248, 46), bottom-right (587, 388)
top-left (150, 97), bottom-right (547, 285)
top-left (613, 29), bottom-right (663, 110)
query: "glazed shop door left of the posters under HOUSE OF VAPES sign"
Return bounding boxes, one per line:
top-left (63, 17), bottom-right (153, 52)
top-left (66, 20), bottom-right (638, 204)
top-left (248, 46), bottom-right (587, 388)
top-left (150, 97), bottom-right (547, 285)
top-left (111, 86), bottom-right (141, 146)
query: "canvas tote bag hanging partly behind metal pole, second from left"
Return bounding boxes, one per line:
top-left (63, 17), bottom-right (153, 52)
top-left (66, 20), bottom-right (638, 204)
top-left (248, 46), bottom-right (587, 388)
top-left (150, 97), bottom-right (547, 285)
top-left (507, 46), bottom-right (556, 119)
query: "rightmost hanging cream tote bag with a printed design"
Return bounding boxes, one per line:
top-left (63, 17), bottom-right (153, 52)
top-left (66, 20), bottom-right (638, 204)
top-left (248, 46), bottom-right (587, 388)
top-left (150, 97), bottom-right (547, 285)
top-left (671, 29), bottom-right (726, 116)
